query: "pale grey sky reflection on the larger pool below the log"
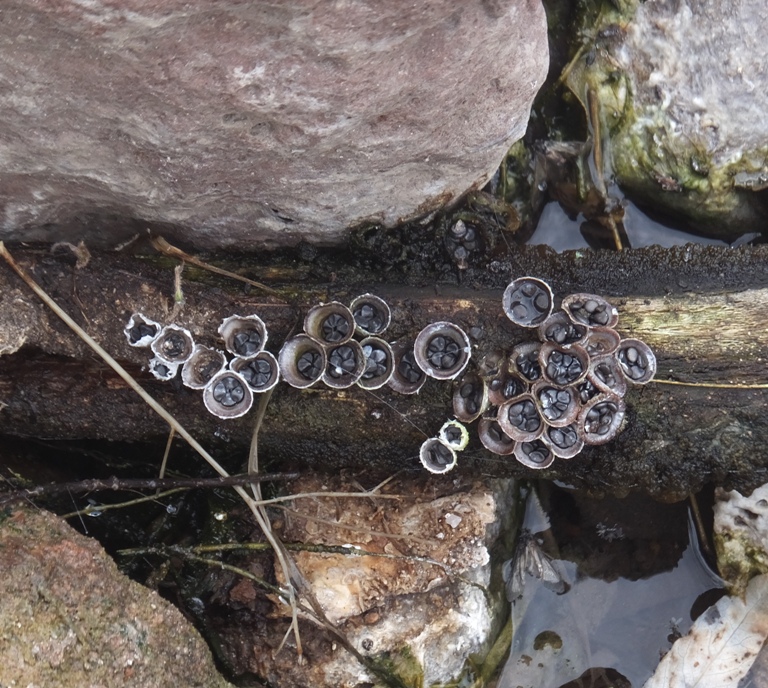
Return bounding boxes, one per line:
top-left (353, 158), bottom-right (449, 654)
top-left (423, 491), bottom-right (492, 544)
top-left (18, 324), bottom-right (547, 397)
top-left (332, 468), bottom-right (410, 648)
top-left (498, 496), bottom-right (721, 688)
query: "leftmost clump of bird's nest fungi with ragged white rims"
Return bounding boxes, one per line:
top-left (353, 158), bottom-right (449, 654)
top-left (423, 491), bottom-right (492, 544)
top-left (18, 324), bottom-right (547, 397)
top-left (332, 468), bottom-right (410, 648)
top-left (124, 313), bottom-right (280, 418)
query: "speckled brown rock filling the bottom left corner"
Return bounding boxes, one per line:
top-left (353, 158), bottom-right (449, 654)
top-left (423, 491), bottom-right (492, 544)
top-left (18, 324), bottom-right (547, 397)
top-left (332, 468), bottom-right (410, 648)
top-left (0, 508), bottom-right (232, 688)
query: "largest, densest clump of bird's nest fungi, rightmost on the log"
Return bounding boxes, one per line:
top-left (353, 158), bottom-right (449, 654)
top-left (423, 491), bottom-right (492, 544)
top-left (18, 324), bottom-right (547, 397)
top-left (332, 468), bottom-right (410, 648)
top-left (453, 277), bottom-right (656, 468)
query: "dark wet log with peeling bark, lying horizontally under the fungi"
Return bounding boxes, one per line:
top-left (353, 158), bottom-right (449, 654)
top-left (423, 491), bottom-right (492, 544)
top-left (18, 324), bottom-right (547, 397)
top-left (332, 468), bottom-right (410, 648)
top-left (0, 247), bottom-right (768, 499)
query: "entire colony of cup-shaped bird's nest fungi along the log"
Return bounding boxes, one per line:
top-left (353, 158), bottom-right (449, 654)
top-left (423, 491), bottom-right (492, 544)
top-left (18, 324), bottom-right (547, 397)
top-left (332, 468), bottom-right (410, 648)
top-left (125, 277), bottom-right (656, 473)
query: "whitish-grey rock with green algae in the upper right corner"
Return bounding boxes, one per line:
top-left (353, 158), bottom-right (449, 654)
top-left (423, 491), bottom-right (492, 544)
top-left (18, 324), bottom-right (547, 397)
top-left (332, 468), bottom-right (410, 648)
top-left (569, 0), bottom-right (768, 239)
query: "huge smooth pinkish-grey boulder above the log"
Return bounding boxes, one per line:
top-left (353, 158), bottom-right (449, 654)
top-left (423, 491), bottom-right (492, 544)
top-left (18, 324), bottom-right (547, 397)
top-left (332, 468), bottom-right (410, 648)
top-left (0, 0), bottom-right (548, 247)
